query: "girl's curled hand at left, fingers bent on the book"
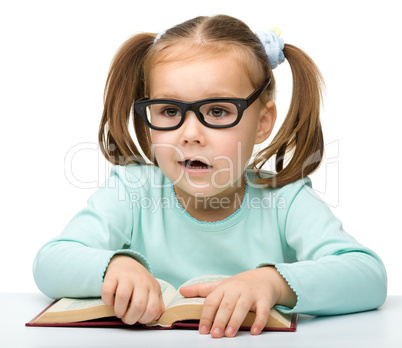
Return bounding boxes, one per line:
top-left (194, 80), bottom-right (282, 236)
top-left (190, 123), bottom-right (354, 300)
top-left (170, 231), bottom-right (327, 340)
top-left (101, 255), bottom-right (165, 325)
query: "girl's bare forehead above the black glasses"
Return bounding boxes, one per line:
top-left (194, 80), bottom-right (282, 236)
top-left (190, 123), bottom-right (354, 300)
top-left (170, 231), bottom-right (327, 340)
top-left (145, 43), bottom-right (254, 100)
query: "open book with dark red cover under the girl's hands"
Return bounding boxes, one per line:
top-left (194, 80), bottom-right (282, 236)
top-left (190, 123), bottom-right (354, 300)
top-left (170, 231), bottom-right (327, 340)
top-left (26, 276), bottom-right (297, 331)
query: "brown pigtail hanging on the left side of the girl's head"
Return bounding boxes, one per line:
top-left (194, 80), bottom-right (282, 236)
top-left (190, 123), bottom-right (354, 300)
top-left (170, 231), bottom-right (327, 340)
top-left (98, 33), bottom-right (155, 165)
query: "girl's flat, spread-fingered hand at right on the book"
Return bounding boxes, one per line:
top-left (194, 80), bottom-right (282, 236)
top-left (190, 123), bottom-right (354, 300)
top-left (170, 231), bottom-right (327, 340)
top-left (180, 267), bottom-right (296, 338)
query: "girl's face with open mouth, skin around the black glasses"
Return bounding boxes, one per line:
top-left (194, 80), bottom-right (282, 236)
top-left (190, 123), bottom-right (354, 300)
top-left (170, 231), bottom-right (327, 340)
top-left (149, 50), bottom-right (276, 197)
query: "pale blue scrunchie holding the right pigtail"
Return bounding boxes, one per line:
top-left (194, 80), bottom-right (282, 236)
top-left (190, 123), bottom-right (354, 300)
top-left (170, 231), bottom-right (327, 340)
top-left (255, 28), bottom-right (285, 69)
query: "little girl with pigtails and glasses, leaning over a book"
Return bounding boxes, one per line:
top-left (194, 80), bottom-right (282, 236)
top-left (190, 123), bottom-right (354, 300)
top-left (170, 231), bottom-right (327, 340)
top-left (34, 16), bottom-right (386, 337)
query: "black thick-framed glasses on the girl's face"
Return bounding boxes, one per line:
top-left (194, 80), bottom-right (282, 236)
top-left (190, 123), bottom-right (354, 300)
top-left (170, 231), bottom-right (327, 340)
top-left (134, 79), bottom-right (271, 131)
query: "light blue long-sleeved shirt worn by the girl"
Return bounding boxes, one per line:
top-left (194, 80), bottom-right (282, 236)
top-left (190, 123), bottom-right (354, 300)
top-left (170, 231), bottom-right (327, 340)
top-left (34, 165), bottom-right (387, 315)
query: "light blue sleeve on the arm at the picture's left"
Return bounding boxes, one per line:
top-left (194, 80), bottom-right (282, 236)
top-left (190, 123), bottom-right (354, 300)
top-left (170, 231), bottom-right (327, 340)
top-left (33, 171), bottom-right (149, 298)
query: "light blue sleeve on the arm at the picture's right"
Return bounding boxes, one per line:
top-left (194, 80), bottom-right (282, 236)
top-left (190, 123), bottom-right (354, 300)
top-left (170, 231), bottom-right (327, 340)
top-left (268, 180), bottom-right (387, 315)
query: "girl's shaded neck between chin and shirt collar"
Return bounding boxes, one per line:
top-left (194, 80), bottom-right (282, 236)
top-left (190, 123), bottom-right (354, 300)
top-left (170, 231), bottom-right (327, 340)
top-left (173, 178), bottom-right (246, 222)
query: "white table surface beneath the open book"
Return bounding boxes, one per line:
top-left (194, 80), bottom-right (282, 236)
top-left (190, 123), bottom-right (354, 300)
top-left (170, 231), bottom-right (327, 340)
top-left (0, 293), bottom-right (402, 348)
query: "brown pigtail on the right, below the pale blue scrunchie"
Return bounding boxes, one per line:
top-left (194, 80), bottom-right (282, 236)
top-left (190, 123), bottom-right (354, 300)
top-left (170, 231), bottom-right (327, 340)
top-left (251, 44), bottom-right (324, 187)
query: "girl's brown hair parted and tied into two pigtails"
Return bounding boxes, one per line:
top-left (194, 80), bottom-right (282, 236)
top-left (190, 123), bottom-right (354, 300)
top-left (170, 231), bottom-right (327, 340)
top-left (99, 15), bottom-right (324, 187)
